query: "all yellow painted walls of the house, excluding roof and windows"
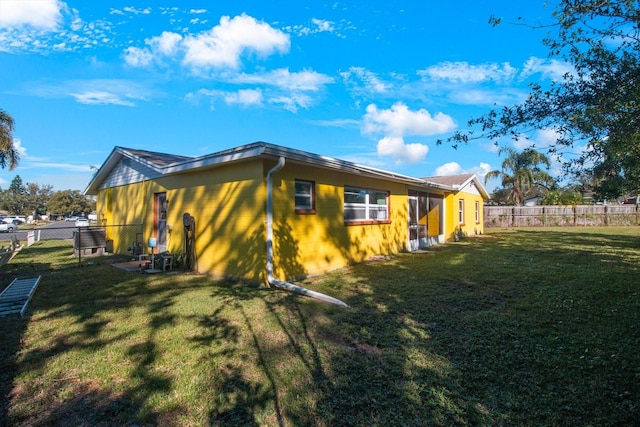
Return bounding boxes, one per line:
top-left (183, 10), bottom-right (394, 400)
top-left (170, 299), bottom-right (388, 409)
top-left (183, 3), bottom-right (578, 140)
top-left (97, 159), bottom-right (482, 283)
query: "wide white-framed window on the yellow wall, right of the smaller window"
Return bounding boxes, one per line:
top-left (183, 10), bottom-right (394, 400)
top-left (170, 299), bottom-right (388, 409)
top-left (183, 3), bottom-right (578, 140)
top-left (344, 187), bottom-right (389, 223)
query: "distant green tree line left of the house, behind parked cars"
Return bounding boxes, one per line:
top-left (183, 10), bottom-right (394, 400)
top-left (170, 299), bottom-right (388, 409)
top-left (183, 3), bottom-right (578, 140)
top-left (0, 175), bottom-right (96, 218)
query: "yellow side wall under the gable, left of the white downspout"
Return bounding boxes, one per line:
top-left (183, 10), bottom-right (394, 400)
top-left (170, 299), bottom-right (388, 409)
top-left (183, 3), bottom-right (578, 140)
top-left (97, 161), bottom-right (265, 280)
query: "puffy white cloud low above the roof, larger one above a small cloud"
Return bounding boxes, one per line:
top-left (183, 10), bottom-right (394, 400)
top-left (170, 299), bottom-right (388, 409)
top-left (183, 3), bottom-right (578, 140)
top-left (363, 102), bottom-right (456, 136)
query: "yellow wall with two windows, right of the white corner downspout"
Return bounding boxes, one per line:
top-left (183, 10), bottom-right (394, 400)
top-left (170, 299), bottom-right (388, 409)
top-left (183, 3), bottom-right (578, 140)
top-left (274, 163), bottom-right (408, 280)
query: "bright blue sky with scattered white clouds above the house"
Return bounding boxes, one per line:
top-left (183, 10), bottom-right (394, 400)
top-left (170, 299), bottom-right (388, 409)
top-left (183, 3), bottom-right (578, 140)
top-left (0, 0), bottom-right (568, 190)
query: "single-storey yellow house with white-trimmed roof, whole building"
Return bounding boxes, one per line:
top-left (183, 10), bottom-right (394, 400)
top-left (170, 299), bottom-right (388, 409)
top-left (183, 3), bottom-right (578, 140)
top-left (85, 142), bottom-right (487, 281)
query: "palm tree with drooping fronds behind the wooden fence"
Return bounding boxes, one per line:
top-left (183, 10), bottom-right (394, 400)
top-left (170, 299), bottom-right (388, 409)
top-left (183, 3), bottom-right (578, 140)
top-left (484, 147), bottom-right (554, 206)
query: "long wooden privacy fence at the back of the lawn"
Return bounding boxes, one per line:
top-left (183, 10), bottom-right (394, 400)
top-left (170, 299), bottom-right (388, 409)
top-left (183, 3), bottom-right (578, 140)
top-left (484, 205), bottom-right (640, 228)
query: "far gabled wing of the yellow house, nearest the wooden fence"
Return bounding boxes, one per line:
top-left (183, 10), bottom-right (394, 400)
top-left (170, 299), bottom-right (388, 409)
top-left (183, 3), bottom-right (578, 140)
top-left (422, 173), bottom-right (489, 240)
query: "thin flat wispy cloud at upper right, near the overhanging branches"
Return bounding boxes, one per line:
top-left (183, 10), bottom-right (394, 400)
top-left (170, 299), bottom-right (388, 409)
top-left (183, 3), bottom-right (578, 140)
top-left (418, 62), bottom-right (516, 83)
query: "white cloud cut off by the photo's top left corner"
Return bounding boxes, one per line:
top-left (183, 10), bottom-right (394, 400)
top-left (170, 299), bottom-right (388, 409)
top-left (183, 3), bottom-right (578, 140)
top-left (0, 0), bottom-right (67, 31)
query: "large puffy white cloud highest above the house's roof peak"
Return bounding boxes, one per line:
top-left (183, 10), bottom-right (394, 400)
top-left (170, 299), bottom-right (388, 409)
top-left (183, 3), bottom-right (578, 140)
top-left (182, 14), bottom-right (290, 71)
